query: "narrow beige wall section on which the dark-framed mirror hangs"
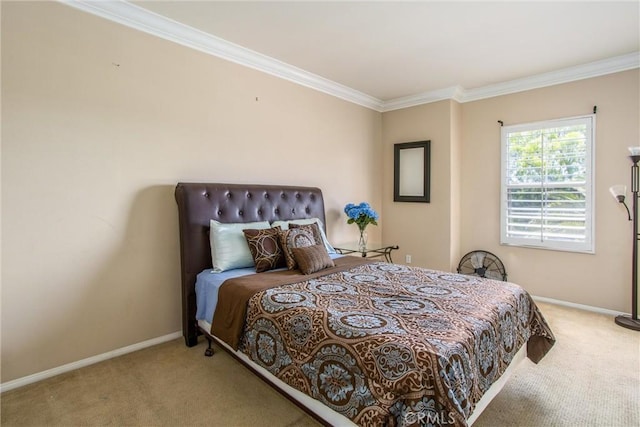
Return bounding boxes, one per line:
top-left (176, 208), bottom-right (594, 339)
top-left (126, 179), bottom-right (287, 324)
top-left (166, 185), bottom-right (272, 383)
top-left (382, 101), bottom-right (458, 270)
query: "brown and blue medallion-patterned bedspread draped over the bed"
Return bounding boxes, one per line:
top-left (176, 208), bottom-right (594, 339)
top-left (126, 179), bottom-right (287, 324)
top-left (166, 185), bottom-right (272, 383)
top-left (240, 262), bottom-right (555, 426)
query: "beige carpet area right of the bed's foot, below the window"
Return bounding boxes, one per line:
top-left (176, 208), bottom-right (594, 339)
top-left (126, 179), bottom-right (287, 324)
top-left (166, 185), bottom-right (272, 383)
top-left (474, 303), bottom-right (640, 427)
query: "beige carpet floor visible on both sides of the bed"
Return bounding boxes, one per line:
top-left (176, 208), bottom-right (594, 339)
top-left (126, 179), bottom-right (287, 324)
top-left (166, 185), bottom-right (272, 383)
top-left (0, 303), bottom-right (640, 427)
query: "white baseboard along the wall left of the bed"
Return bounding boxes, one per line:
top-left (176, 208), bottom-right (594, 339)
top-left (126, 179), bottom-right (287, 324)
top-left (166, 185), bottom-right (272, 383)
top-left (0, 332), bottom-right (182, 393)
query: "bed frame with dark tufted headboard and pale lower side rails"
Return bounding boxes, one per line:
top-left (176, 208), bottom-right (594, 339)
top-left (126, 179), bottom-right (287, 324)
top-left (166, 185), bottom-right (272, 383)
top-left (175, 183), bottom-right (526, 426)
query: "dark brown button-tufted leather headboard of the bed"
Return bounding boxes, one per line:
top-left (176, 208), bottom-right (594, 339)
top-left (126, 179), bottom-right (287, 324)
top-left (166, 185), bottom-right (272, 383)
top-left (175, 182), bottom-right (326, 347)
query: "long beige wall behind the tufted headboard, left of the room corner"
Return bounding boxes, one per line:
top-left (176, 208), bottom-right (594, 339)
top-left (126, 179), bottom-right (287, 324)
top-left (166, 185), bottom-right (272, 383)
top-left (1, 2), bottom-right (382, 382)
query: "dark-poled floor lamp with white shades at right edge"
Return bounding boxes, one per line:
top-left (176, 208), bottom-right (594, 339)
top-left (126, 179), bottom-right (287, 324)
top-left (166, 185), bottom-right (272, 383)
top-left (609, 147), bottom-right (640, 331)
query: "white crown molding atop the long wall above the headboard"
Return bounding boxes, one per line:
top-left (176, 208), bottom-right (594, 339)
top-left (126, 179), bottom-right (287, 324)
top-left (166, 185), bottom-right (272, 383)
top-left (58, 0), bottom-right (383, 111)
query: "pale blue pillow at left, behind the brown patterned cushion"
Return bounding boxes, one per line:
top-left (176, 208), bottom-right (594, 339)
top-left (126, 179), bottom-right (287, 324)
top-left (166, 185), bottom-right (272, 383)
top-left (209, 219), bottom-right (271, 273)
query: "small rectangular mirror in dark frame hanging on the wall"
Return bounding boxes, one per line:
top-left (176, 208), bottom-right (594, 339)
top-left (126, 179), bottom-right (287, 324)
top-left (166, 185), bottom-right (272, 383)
top-left (393, 141), bottom-right (431, 203)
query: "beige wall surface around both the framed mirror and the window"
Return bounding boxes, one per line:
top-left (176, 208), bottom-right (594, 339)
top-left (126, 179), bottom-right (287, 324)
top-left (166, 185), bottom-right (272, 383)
top-left (382, 69), bottom-right (640, 312)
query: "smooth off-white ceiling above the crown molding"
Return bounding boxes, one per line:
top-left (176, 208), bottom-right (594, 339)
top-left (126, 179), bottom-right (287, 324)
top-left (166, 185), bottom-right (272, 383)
top-left (74, 0), bottom-right (640, 110)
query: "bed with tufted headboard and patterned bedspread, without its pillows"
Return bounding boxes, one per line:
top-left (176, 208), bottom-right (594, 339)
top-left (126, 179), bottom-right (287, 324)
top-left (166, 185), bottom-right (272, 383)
top-left (175, 183), bottom-right (555, 426)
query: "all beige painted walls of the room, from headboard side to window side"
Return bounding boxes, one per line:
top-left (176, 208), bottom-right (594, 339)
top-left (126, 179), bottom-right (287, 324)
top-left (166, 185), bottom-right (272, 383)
top-left (1, 2), bottom-right (640, 382)
